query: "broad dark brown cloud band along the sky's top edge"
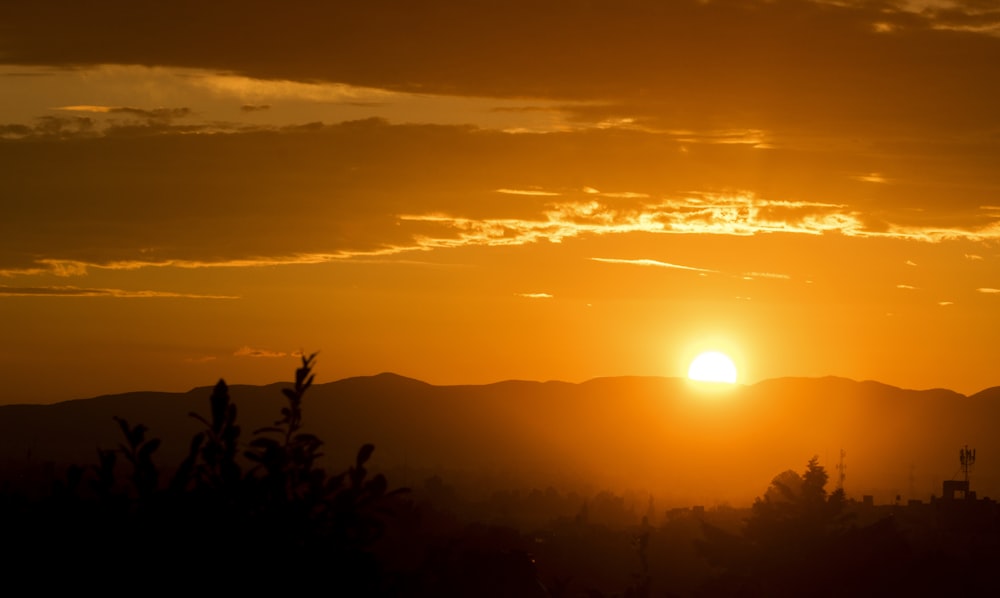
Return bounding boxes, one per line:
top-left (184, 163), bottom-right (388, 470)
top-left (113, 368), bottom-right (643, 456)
top-left (0, 0), bottom-right (1000, 142)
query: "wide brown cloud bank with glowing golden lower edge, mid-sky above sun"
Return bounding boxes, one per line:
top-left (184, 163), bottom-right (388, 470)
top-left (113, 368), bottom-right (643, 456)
top-left (0, 117), bottom-right (1000, 286)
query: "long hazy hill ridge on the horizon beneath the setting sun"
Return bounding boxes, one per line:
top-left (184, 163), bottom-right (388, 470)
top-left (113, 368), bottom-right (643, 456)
top-left (0, 374), bottom-right (1000, 505)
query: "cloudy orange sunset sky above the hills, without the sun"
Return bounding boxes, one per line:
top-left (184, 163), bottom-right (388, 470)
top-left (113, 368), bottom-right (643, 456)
top-left (0, 0), bottom-right (1000, 403)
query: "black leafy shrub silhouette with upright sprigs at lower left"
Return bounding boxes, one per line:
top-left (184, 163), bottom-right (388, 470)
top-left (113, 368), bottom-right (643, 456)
top-left (0, 354), bottom-right (406, 595)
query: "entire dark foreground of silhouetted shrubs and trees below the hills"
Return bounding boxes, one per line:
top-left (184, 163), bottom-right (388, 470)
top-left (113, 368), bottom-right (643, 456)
top-left (0, 356), bottom-right (1000, 598)
